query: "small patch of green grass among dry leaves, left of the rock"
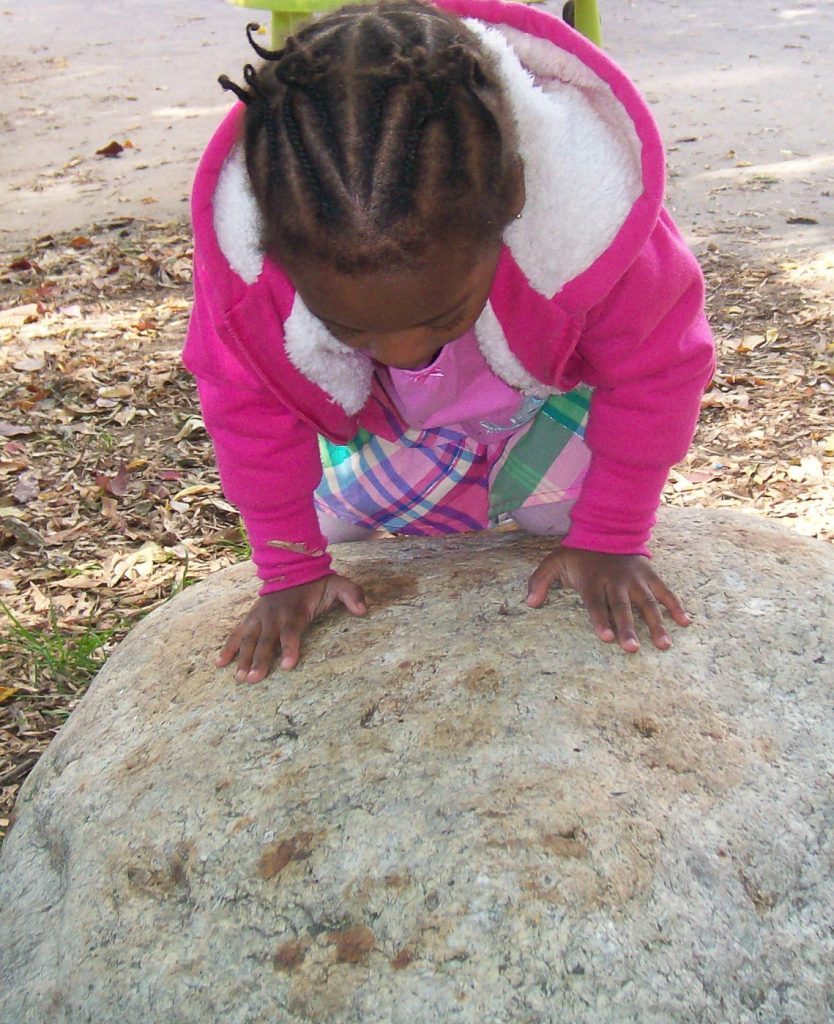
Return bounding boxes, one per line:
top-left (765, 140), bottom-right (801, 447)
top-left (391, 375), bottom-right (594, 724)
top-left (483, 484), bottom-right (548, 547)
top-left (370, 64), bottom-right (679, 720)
top-left (0, 602), bottom-right (116, 693)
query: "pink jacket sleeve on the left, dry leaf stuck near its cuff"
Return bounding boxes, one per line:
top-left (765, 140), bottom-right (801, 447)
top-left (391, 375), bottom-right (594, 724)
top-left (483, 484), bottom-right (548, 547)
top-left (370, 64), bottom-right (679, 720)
top-left (183, 264), bottom-right (332, 595)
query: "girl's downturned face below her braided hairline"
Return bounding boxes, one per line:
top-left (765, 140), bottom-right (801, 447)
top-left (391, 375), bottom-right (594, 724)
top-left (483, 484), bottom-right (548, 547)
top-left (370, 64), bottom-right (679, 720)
top-left (288, 243), bottom-right (501, 370)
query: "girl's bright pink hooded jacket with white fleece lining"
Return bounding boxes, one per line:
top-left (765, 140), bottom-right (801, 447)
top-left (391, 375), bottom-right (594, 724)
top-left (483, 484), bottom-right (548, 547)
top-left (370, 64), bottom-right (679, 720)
top-left (184, 0), bottom-right (713, 594)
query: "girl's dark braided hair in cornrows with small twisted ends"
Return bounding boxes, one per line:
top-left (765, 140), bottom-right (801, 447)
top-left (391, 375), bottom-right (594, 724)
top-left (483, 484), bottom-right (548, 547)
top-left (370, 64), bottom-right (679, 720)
top-left (219, 0), bottom-right (518, 273)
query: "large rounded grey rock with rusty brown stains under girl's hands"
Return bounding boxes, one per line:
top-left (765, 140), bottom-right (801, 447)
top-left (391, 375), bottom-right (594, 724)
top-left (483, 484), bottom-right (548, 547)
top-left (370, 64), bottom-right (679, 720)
top-left (0, 511), bottom-right (834, 1024)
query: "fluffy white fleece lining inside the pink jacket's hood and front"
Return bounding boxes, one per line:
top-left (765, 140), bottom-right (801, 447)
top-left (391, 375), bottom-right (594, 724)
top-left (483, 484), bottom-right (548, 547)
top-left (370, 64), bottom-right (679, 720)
top-left (213, 18), bottom-right (641, 415)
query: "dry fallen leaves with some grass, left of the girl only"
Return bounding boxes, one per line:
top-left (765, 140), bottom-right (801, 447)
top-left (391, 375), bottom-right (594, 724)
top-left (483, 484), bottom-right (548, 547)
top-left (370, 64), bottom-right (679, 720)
top-left (0, 218), bottom-right (247, 835)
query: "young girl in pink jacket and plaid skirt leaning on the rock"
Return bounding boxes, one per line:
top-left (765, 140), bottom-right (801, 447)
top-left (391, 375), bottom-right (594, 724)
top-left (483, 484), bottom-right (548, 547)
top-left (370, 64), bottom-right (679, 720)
top-left (184, 0), bottom-right (713, 682)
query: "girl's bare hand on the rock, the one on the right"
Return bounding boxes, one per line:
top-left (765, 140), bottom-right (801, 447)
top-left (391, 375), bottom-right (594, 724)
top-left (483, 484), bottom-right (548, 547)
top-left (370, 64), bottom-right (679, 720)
top-left (527, 547), bottom-right (692, 653)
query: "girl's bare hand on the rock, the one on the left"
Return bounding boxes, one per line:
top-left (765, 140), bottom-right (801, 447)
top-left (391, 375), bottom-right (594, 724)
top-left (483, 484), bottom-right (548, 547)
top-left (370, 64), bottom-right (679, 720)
top-left (215, 574), bottom-right (368, 683)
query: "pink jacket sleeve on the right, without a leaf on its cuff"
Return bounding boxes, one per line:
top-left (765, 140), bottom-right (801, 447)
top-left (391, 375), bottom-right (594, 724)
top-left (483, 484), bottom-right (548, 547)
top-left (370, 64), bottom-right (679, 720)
top-left (564, 211), bottom-right (715, 555)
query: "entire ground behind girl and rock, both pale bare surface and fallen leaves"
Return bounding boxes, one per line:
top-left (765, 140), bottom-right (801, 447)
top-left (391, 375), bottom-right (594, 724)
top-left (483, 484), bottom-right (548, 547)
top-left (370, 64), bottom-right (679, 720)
top-left (0, 0), bottom-right (834, 835)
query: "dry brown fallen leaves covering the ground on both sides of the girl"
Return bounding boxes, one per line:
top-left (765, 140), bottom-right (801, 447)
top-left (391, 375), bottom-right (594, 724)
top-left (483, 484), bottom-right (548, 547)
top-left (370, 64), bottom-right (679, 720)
top-left (0, 224), bottom-right (834, 837)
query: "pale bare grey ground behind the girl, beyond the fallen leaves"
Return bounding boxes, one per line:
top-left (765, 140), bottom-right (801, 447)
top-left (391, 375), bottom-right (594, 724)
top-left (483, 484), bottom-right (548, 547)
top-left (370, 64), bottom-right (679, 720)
top-left (0, 0), bottom-right (834, 276)
